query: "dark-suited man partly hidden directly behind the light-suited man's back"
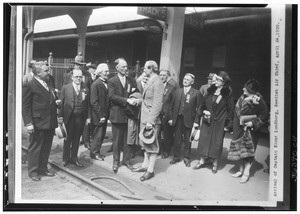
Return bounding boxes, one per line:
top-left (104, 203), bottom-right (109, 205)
top-left (159, 69), bottom-right (179, 159)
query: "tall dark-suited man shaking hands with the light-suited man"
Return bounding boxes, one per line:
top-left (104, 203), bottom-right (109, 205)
top-left (108, 58), bottom-right (136, 173)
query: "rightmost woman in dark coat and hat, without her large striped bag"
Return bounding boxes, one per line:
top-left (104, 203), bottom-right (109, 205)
top-left (231, 79), bottom-right (269, 183)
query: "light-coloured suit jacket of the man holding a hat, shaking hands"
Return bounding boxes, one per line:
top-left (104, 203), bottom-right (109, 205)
top-left (141, 76), bottom-right (164, 125)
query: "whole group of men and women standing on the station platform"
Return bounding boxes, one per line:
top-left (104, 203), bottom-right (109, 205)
top-left (22, 55), bottom-right (269, 183)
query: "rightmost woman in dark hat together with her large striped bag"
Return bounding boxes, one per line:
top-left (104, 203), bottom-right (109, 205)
top-left (228, 79), bottom-right (269, 183)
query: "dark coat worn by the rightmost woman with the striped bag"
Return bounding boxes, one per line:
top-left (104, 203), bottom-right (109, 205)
top-left (232, 94), bottom-right (269, 149)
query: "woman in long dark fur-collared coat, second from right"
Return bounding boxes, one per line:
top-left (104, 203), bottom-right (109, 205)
top-left (193, 71), bottom-right (234, 174)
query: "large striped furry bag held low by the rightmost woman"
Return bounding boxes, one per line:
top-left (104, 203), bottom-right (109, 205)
top-left (227, 129), bottom-right (255, 161)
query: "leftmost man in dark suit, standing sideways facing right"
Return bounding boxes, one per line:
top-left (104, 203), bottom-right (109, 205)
top-left (22, 62), bottom-right (57, 181)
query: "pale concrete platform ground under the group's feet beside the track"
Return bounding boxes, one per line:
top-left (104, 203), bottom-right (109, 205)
top-left (21, 127), bottom-right (269, 204)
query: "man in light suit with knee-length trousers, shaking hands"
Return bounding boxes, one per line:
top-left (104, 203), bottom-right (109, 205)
top-left (132, 61), bottom-right (164, 181)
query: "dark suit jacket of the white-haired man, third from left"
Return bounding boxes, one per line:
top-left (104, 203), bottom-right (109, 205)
top-left (90, 78), bottom-right (109, 125)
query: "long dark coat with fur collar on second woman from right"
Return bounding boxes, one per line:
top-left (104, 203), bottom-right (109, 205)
top-left (197, 85), bottom-right (234, 159)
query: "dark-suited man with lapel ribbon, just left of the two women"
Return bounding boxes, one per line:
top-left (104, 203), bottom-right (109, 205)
top-left (169, 73), bottom-right (201, 167)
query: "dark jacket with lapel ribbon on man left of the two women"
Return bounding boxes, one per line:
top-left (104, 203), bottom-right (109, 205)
top-left (170, 88), bottom-right (202, 128)
